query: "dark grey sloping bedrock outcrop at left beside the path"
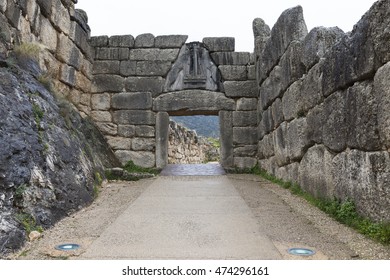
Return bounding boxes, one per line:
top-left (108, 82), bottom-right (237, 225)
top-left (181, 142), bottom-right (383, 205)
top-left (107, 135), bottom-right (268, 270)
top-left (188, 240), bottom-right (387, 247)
top-left (0, 54), bottom-right (119, 255)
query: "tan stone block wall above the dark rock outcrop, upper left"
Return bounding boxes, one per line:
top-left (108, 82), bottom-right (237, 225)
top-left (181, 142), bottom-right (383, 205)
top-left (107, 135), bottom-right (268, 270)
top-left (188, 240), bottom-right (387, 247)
top-left (0, 0), bottom-right (93, 115)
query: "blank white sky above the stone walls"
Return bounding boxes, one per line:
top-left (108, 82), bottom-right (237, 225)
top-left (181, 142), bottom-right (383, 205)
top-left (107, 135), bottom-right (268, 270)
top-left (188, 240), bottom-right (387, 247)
top-left (76, 0), bottom-right (375, 52)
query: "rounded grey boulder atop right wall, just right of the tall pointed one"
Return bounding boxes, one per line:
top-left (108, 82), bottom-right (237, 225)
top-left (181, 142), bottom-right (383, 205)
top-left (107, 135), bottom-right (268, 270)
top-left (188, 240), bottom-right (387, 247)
top-left (302, 27), bottom-right (344, 69)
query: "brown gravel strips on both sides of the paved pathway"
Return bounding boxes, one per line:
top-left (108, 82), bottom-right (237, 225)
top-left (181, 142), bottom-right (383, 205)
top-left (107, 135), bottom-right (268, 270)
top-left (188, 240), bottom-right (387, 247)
top-left (10, 175), bottom-right (390, 260)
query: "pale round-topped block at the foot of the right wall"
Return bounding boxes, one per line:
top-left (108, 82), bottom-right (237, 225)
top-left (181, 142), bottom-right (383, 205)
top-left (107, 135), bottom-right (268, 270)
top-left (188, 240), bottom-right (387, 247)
top-left (298, 145), bottom-right (334, 198)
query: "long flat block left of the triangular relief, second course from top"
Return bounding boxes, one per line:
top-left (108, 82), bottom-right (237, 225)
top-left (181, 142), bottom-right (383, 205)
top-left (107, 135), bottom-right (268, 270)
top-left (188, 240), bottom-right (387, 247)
top-left (130, 49), bottom-right (180, 62)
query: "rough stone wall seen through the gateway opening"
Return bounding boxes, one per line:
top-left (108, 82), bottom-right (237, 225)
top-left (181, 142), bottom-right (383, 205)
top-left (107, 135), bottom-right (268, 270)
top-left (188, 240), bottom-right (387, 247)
top-left (168, 121), bottom-right (219, 164)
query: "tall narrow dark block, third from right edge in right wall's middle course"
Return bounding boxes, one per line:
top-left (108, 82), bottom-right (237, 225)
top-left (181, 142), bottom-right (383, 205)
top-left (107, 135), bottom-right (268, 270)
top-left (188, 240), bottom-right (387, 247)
top-left (322, 91), bottom-right (349, 152)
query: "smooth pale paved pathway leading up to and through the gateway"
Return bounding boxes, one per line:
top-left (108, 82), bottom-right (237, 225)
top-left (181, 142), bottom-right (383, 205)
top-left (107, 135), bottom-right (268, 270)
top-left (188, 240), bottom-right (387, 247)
top-left (81, 165), bottom-right (281, 259)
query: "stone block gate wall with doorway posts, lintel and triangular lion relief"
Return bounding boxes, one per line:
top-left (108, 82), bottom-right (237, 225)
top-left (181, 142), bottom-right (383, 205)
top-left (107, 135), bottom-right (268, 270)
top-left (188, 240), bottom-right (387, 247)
top-left (90, 34), bottom-right (258, 168)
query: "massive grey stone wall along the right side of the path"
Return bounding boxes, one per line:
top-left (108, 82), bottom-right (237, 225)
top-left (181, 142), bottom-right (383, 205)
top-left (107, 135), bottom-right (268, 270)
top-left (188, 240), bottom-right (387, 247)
top-left (254, 1), bottom-right (390, 221)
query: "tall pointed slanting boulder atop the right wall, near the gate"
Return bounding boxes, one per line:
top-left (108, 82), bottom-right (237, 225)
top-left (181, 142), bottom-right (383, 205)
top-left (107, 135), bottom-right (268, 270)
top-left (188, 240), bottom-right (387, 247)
top-left (258, 6), bottom-right (307, 83)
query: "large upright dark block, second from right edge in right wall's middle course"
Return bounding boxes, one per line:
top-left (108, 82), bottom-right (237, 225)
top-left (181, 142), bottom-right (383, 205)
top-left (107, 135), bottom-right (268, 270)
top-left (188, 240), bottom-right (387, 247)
top-left (346, 82), bottom-right (381, 151)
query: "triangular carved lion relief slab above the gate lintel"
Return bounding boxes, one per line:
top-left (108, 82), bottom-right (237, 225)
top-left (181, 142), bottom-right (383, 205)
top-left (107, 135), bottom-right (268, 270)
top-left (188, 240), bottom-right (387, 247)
top-left (164, 42), bottom-right (223, 92)
